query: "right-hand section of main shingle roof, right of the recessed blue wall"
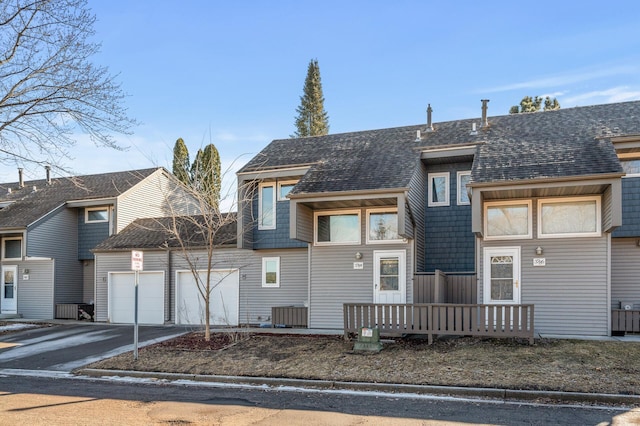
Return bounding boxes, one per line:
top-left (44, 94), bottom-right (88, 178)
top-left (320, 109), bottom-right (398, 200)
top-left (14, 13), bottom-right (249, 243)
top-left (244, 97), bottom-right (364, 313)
top-left (471, 102), bottom-right (640, 183)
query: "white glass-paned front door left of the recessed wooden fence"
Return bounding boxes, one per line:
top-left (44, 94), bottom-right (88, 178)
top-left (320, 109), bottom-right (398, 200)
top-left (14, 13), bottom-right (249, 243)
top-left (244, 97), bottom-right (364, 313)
top-left (373, 250), bottom-right (407, 303)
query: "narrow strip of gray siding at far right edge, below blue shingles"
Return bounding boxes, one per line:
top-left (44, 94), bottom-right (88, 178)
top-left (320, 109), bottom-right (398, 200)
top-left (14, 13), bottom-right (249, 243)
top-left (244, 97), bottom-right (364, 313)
top-left (611, 238), bottom-right (640, 309)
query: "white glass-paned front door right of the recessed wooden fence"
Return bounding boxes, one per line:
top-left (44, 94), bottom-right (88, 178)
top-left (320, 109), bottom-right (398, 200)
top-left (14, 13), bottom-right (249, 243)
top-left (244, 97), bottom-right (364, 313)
top-left (483, 247), bottom-right (521, 305)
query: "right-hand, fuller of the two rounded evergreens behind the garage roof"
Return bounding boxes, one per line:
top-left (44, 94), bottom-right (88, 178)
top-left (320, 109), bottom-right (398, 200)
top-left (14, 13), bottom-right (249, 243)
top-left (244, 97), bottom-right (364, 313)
top-left (191, 143), bottom-right (222, 208)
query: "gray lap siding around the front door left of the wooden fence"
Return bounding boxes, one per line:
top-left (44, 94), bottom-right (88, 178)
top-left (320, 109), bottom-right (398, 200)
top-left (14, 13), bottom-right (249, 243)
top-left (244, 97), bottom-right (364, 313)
top-left (309, 216), bottom-right (413, 329)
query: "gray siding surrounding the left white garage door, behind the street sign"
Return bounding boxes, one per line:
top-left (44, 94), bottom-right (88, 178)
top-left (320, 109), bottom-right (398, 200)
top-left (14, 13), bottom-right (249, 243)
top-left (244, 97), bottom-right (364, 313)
top-left (95, 251), bottom-right (169, 321)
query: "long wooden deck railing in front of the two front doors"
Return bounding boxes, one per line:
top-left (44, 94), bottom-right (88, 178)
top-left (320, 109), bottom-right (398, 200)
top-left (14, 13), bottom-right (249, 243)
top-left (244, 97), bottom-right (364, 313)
top-left (344, 303), bottom-right (534, 344)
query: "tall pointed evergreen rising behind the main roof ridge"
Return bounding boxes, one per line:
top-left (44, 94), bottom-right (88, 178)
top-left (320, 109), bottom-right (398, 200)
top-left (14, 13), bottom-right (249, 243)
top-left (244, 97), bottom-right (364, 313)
top-left (293, 59), bottom-right (329, 138)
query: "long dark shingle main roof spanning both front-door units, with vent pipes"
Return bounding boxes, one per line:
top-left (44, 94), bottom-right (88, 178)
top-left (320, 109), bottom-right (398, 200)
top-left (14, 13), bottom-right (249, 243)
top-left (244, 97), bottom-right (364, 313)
top-left (240, 101), bottom-right (640, 194)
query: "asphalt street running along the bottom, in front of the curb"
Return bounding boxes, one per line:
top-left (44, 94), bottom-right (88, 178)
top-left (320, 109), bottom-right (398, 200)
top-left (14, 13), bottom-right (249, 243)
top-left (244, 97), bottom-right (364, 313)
top-left (0, 370), bottom-right (640, 426)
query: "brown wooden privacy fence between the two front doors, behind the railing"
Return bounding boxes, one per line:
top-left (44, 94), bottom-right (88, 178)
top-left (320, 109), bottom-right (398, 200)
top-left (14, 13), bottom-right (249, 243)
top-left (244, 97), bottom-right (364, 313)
top-left (413, 271), bottom-right (478, 304)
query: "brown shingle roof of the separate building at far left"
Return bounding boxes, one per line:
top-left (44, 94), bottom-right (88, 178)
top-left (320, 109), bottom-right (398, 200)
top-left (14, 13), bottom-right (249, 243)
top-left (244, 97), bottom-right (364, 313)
top-left (0, 168), bottom-right (158, 228)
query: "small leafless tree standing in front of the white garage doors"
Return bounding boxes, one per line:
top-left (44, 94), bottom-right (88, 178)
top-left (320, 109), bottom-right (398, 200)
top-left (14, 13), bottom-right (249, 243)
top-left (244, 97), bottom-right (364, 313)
top-left (155, 161), bottom-right (255, 341)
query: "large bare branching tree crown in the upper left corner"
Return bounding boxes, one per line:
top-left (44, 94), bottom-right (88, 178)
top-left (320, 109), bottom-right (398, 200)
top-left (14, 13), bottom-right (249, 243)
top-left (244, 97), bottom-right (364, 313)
top-left (0, 0), bottom-right (136, 173)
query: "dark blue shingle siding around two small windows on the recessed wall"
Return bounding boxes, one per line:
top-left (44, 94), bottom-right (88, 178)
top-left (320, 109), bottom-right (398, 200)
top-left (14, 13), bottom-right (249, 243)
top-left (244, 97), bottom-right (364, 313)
top-left (421, 163), bottom-right (475, 273)
